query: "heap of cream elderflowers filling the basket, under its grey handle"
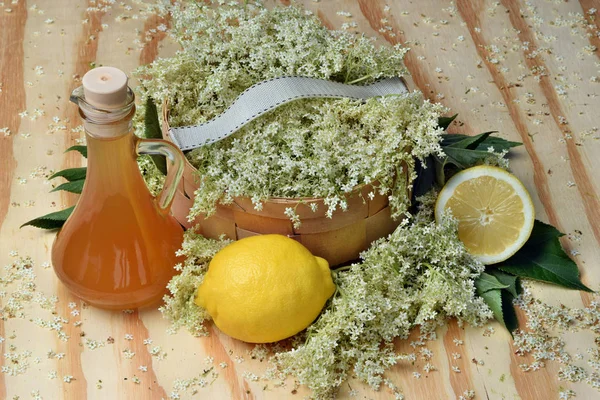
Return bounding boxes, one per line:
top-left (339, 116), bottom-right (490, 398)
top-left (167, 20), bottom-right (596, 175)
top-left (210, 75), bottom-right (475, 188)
top-left (137, 1), bottom-right (445, 224)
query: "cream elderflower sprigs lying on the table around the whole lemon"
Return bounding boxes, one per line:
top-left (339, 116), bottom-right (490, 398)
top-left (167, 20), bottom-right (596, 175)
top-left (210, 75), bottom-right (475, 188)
top-left (161, 202), bottom-right (492, 398)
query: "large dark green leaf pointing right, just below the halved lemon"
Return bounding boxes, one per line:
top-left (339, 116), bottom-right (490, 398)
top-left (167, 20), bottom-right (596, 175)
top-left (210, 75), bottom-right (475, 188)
top-left (498, 220), bottom-right (593, 292)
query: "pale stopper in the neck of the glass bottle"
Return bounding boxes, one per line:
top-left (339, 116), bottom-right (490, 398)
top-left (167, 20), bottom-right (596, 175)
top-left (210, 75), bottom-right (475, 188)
top-left (82, 67), bottom-right (127, 110)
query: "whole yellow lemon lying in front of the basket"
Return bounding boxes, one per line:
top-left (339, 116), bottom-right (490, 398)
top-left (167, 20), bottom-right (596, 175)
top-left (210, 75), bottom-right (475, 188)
top-left (196, 235), bottom-right (335, 343)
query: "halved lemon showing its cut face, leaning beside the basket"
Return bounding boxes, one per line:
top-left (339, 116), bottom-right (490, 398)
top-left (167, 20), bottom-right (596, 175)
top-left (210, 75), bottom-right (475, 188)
top-left (435, 165), bottom-right (535, 264)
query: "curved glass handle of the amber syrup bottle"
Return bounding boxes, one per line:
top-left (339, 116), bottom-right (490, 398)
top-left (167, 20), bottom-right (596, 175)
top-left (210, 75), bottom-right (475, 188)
top-left (136, 139), bottom-right (185, 213)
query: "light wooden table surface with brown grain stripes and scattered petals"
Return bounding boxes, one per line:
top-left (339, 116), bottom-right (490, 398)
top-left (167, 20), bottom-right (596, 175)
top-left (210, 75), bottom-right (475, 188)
top-left (0, 0), bottom-right (600, 400)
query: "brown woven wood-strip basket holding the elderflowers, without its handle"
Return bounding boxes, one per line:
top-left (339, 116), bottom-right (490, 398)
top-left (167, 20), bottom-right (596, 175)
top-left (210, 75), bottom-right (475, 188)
top-left (162, 104), bottom-right (407, 266)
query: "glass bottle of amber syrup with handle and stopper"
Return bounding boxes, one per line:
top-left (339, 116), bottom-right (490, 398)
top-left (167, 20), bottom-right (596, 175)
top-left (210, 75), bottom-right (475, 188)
top-left (52, 67), bottom-right (184, 309)
